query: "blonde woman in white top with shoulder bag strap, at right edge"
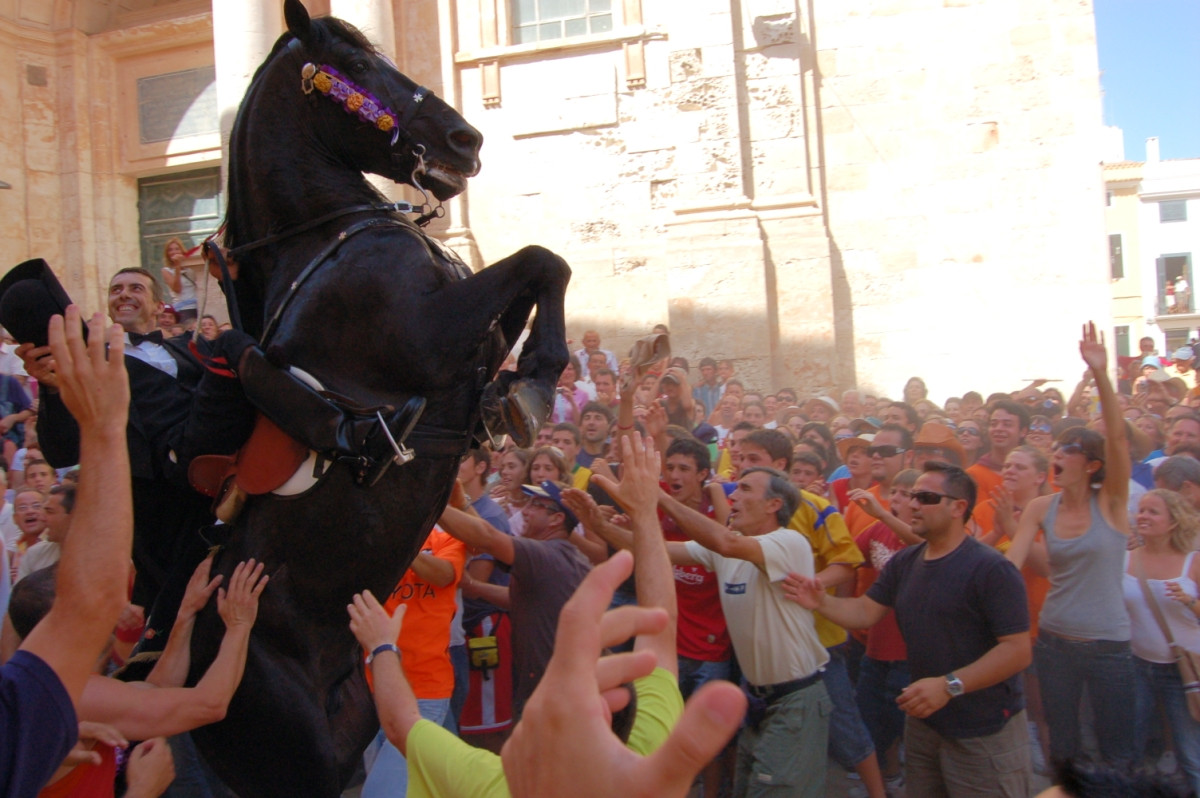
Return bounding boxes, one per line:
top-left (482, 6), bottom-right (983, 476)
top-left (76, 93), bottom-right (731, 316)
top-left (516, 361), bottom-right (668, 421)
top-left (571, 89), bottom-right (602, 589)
top-left (1123, 490), bottom-right (1200, 794)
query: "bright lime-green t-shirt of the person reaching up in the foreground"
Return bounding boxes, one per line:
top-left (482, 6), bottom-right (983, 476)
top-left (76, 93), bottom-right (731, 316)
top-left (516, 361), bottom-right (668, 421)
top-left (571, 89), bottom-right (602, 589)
top-left (407, 668), bottom-right (683, 798)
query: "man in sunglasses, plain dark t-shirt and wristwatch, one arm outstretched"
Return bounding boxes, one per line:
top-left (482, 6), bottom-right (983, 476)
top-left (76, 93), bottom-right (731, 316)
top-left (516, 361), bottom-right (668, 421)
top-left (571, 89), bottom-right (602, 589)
top-left (784, 462), bottom-right (1032, 797)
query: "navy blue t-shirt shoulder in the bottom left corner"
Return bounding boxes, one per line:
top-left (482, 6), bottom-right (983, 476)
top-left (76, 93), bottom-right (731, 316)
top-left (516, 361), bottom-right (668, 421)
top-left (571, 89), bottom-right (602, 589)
top-left (0, 652), bottom-right (79, 798)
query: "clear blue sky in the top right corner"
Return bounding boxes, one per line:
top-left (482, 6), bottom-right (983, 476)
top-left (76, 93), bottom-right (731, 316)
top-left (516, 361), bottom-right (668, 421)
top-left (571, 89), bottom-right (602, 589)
top-left (1094, 0), bottom-right (1200, 161)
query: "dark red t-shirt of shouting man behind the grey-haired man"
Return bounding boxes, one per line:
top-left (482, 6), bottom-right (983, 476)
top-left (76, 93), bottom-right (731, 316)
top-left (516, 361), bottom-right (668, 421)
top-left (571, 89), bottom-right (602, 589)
top-left (659, 498), bottom-right (733, 662)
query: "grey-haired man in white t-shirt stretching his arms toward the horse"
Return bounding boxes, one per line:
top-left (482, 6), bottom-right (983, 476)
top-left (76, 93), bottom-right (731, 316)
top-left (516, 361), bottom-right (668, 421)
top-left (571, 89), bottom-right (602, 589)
top-left (659, 468), bottom-right (833, 798)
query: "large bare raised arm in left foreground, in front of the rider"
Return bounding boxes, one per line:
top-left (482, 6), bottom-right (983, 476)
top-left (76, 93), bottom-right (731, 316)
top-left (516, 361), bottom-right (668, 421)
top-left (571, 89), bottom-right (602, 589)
top-left (20, 305), bottom-right (133, 707)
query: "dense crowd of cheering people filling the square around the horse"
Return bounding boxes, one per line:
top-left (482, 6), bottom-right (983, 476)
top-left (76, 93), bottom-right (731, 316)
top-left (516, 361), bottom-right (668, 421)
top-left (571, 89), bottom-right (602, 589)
top-left (7, 269), bottom-right (1200, 798)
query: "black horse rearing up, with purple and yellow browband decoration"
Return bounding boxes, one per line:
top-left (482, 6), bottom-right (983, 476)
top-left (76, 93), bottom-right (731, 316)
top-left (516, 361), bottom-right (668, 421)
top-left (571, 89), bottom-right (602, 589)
top-left (191, 0), bottom-right (570, 798)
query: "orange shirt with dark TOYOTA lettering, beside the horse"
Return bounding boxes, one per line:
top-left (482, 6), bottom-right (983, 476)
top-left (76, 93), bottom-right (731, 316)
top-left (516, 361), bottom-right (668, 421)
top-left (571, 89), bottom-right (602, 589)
top-left (379, 527), bottom-right (467, 698)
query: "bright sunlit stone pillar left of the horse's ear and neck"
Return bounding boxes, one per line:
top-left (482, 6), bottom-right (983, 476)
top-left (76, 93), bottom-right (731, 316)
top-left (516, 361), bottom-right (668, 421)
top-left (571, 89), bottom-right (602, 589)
top-left (212, 0), bottom-right (283, 174)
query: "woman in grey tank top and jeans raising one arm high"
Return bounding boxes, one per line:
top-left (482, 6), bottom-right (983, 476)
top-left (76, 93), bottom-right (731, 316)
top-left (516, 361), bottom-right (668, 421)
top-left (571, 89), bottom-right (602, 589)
top-left (1007, 323), bottom-right (1134, 768)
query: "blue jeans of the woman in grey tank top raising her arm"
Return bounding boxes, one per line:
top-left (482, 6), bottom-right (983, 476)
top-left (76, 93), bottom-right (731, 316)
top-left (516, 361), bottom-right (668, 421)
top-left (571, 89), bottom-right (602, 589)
top-left (1033, 631), bottom-right (1135, 769)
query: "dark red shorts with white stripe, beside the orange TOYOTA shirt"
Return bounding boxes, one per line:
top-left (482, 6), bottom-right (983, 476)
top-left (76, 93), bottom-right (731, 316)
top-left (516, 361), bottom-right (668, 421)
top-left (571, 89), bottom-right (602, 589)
top-left (458, 612), bottom-right (512, 737)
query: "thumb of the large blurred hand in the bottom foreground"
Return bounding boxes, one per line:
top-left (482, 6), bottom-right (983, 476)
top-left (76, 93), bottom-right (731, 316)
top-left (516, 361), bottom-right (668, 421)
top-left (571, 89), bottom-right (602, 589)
top-left (640, 682), bottom-right (746, 794)
